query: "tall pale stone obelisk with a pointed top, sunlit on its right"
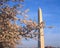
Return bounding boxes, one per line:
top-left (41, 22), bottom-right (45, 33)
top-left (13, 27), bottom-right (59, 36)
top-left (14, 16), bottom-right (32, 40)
top-left (38, 8), bottom-right (44, 48)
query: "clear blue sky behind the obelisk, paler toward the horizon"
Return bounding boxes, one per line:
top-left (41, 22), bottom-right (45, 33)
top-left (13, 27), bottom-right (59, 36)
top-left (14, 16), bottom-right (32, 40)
top-left (19, 0), bottom-right (60, 46)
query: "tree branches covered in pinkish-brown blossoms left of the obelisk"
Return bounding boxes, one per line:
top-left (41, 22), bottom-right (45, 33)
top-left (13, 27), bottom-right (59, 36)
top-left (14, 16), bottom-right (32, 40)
top-left (0, 0), bottom-right (37, 48)
